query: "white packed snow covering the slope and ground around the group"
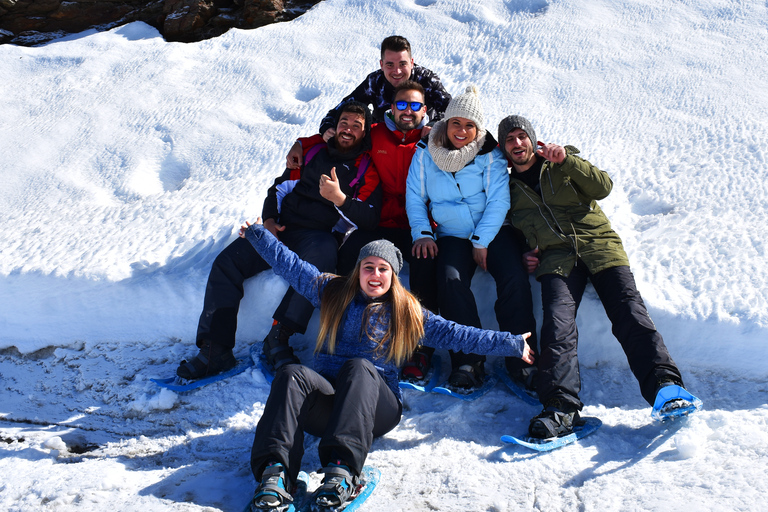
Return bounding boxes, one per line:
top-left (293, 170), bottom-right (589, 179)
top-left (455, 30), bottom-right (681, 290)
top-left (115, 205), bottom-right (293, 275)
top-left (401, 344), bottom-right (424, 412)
top-left (0, 0), bottom-right (768, 512)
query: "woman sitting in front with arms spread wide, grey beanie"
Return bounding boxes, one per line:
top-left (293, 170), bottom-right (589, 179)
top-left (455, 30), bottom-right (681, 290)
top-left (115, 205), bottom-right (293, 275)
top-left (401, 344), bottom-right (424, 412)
top-left (240, 221), bottom-right (532, 510)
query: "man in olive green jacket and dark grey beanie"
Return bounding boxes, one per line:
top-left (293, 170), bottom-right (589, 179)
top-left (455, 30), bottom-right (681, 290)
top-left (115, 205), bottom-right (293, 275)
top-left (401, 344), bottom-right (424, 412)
top-left (498, 116), bottom-right (683, 438)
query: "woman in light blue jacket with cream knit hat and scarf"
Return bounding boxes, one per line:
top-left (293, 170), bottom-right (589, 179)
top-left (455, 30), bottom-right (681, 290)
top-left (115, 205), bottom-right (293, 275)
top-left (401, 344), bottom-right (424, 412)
top-left (405, 86), bottom-right (514, 390)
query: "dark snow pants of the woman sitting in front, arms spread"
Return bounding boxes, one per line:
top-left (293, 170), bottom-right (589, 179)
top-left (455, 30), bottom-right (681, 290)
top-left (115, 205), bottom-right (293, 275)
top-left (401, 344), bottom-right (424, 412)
top-left (251, 359), bottom-right (402, 482)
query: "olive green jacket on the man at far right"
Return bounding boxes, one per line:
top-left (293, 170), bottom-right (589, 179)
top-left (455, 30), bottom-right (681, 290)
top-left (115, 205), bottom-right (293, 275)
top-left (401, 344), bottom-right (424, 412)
top-left (509, 146), bottom-right (629, 279)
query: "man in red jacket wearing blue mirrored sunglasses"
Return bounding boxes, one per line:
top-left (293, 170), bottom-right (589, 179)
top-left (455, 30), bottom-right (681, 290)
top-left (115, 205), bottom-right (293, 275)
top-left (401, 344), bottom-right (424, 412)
top-left (287, 80), bottom-right (437, 380)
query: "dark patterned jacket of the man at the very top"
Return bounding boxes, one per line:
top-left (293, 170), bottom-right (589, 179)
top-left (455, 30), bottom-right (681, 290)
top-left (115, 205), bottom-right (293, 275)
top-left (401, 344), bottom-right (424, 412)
top-left (320, 66), bottom-right (451, 133)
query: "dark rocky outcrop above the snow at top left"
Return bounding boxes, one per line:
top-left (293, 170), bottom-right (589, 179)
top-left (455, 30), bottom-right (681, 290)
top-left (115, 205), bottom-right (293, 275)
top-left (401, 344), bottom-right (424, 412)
top-left (0, 0), bottom-right (320, 46)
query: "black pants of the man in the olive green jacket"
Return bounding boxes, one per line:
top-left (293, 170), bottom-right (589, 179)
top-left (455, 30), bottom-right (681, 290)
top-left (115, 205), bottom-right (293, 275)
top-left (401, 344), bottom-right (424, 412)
top-left (536, 260), bottom-right (682, 410)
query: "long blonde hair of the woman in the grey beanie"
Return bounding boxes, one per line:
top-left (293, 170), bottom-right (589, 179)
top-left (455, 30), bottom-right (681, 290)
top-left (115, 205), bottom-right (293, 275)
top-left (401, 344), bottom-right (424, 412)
top-left (315, 263), bottom-right (429, 366)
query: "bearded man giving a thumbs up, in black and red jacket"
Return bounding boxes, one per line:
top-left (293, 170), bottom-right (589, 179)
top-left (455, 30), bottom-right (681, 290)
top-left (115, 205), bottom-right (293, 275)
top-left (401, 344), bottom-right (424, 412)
top-left (176, 102), bottom-right (381, 379)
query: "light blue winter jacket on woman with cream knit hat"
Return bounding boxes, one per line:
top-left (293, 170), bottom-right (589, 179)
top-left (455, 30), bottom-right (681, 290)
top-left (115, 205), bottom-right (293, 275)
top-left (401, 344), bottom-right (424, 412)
top-left (405, 133), bottom-right (509, 247)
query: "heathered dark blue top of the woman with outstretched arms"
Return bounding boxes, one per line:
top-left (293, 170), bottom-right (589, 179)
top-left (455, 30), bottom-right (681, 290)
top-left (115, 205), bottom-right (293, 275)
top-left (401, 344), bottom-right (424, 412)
top-left (245, 224), bottom-right (525, 400)
